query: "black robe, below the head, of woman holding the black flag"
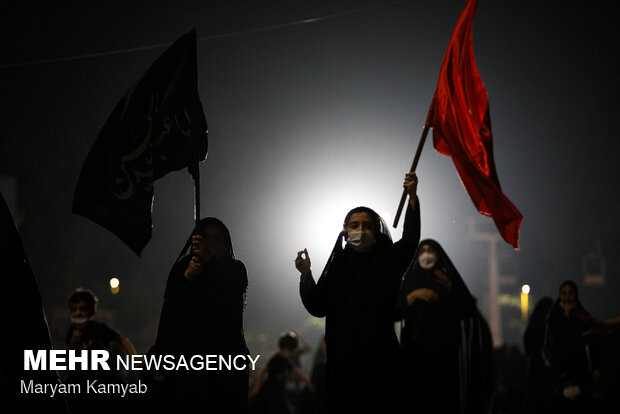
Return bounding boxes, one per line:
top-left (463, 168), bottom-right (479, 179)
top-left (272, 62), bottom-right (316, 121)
top-left (155, 251), bottom-right (249, 413)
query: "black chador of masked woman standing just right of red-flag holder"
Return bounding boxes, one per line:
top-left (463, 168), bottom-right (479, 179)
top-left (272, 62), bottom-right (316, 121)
top-left (398, 240), bottom-right (494, 413)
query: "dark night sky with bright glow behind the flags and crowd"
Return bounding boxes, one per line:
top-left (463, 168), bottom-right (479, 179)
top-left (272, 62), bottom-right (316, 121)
top-left (0, 0), bottom-right (620, 351)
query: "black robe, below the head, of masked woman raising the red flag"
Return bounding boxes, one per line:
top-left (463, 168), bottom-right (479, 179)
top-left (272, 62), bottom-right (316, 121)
top-left (299, 200), bottom-right (420, 413)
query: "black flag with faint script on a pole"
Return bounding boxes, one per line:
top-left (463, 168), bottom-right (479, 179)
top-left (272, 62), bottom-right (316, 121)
top-left (73, 30), bottom-right (207, 255)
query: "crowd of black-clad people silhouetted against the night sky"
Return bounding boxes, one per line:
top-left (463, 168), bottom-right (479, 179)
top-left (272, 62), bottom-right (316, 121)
top-left (6, 173), bottom-right (620, 414)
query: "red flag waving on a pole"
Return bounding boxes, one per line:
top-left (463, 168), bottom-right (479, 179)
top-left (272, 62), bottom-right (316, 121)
top-left (426, 0), bottom-right (523, 249)
